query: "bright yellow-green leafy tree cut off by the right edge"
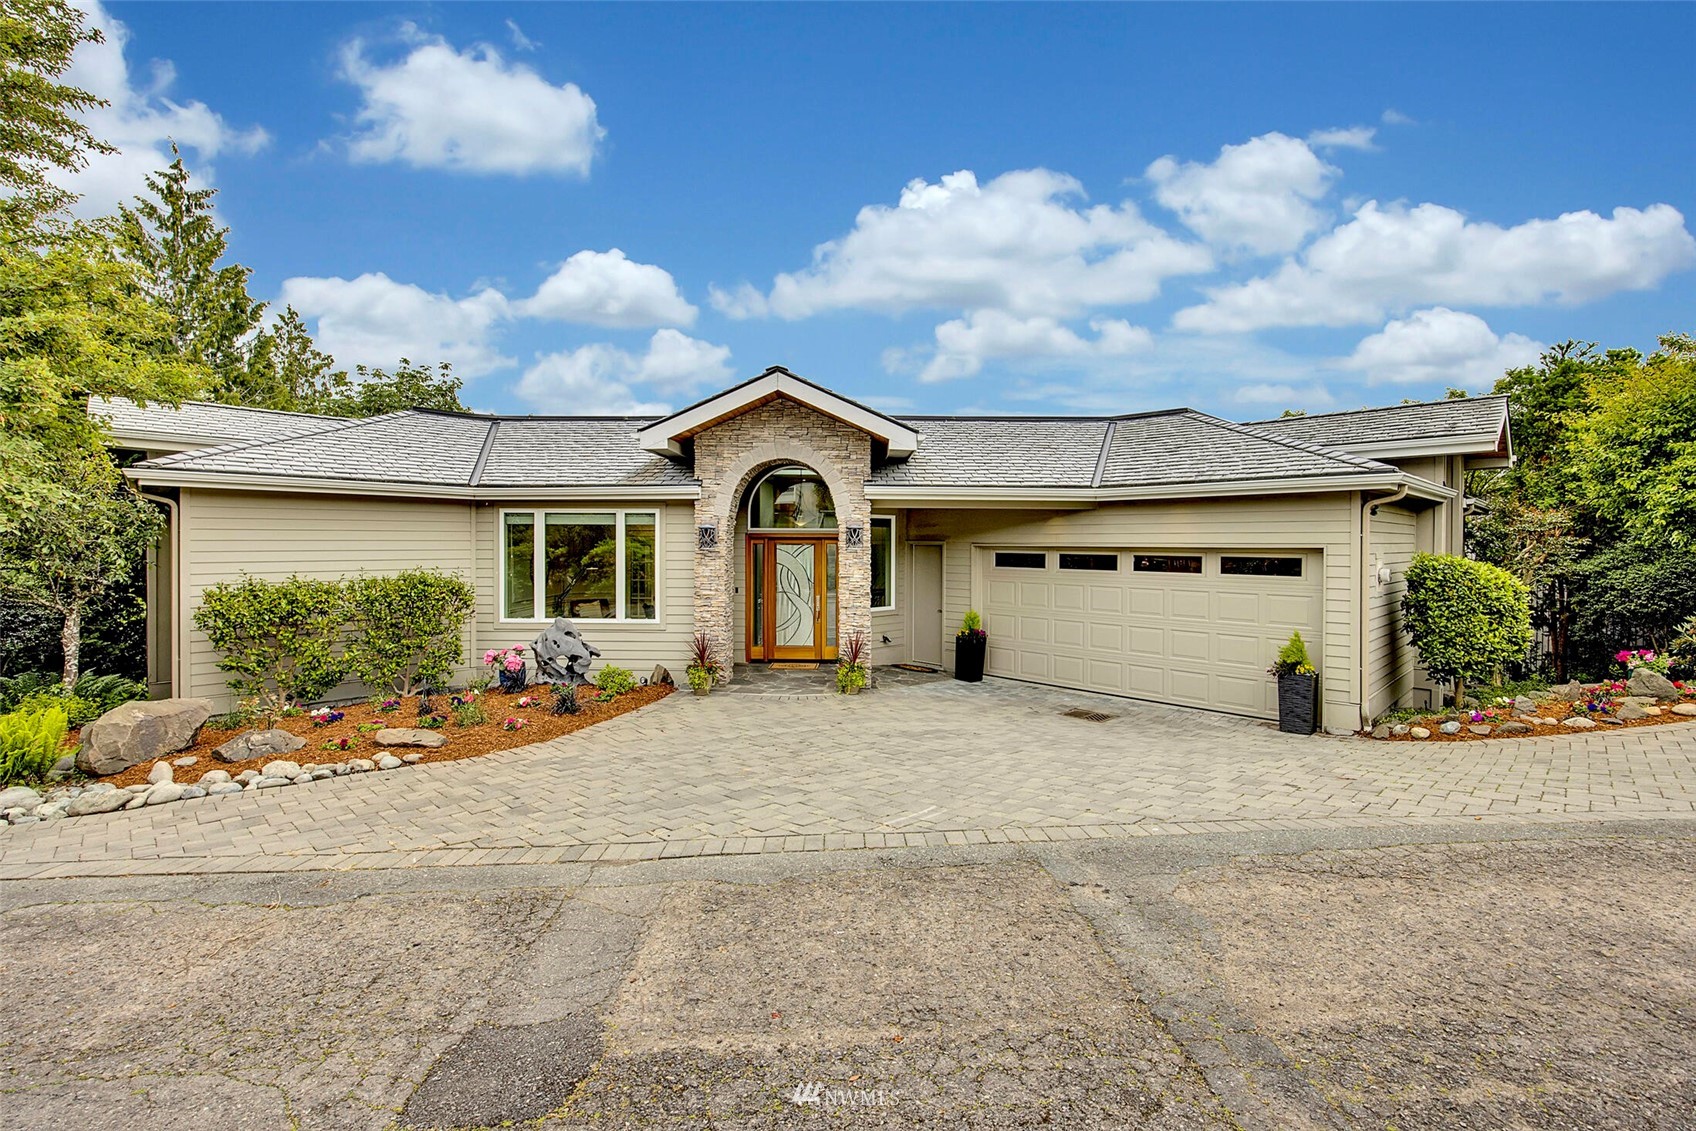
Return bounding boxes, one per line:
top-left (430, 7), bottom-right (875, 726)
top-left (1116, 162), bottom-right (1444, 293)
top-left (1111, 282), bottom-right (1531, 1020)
top-left (1569, 334), bottom-right (1696, 548)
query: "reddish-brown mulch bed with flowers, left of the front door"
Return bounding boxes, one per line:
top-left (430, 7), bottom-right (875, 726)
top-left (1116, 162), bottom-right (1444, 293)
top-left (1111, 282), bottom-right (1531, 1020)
top-left (87, 685), bottom-right (675, 788)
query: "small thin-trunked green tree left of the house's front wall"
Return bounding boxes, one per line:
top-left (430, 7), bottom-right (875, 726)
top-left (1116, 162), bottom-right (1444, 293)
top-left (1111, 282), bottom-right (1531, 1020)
top-left (0, 454), bottom-right (165, 694)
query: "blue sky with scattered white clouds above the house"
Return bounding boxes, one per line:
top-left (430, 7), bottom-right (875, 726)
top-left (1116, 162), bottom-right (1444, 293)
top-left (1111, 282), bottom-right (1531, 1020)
top-left (59, 3), bottom-right (1696, 419)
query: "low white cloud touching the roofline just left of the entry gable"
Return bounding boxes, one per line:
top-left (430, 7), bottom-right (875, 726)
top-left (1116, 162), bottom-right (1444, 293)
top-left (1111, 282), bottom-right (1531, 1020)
top-left (517, 329), bottom-right (731, 415)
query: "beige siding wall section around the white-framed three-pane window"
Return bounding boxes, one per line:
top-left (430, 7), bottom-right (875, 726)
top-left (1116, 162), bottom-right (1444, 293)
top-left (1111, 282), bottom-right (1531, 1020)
top-left (468, 500), bottom-right (695, 678)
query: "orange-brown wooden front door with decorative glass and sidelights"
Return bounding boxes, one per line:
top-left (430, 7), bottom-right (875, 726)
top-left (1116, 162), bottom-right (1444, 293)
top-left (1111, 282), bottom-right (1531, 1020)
top-left (748, 534), bottom-right (836, 660)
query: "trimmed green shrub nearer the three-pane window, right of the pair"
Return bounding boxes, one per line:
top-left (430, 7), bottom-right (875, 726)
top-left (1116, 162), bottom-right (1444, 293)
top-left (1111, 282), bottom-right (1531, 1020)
top-left (346, 570), bottom-right (477, 695)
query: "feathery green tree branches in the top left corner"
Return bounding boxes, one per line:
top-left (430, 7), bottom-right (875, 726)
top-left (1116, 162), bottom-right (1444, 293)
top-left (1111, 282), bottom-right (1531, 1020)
top-left (0, 0), bottom-right (114, 244)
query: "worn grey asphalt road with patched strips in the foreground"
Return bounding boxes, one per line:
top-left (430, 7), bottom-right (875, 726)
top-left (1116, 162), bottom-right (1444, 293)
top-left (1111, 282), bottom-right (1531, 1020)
top-left (0, 822), bottom-right (1696, 1131)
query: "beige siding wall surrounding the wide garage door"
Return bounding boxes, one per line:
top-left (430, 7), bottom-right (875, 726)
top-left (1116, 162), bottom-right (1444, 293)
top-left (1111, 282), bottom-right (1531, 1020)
top-left (906, 492), bottom-right (1360, 731)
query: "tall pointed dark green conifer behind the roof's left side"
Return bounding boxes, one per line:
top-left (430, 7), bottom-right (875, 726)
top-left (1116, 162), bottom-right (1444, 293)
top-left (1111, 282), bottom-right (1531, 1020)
top-left (115, 144), bottom-right (265, 393)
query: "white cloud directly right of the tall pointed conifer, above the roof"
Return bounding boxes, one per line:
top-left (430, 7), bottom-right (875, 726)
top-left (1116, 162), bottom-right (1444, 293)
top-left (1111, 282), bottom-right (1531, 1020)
top-left (278, 273), bottom-right (512, 378)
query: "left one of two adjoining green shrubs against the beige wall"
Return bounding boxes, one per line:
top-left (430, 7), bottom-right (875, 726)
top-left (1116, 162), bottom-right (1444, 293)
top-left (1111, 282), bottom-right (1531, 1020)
top-left (195, 575), bottom-right (348, 716)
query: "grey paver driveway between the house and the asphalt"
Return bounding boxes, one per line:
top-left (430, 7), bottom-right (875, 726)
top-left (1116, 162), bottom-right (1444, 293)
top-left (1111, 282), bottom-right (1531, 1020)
top-left (0, 682), bottom-right (1696, 878)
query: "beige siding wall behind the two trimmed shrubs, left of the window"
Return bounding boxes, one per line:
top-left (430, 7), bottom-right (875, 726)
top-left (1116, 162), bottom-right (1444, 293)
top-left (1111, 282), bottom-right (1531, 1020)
top-left (176, 488), bottom-right (471, 709)
